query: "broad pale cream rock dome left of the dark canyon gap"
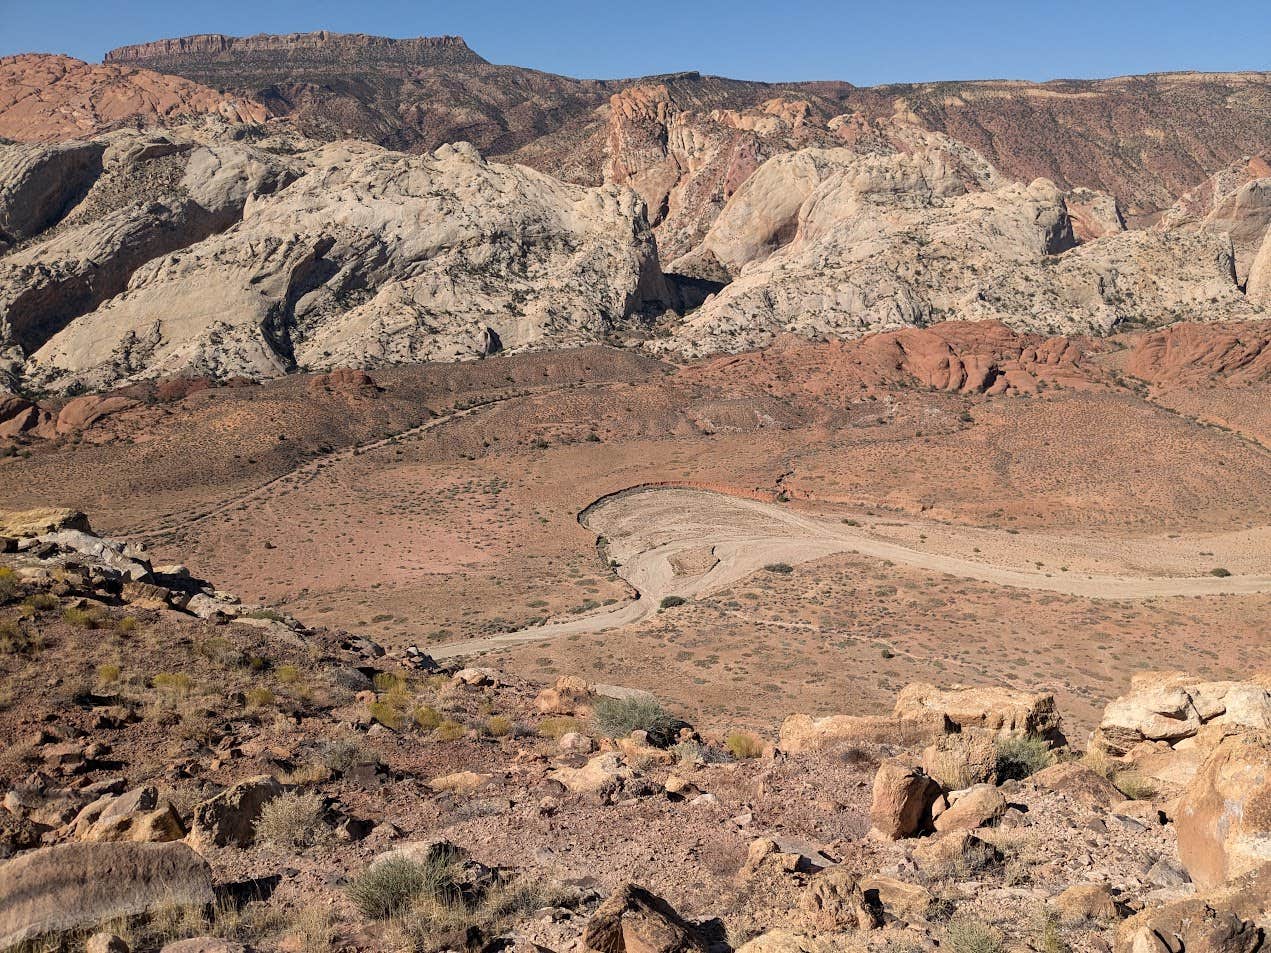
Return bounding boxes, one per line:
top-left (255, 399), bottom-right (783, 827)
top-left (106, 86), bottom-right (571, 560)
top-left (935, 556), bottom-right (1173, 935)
top-left (22, 144), bottom-right (667, 386)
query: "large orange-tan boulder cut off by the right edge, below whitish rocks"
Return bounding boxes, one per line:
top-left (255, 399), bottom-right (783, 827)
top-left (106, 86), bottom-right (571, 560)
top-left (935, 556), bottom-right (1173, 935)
top-left (1174, 731), bottom-right (1271, 887)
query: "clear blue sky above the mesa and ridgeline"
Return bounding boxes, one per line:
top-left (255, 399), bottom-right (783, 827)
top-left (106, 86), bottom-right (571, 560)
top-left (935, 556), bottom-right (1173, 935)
top-left (0, 0), bottom-right (1271, 85)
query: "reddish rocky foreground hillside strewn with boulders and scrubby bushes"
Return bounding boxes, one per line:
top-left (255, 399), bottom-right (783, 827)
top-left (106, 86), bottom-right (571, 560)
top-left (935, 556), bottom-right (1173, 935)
top-left (0, 511), bottom-right (1271, 953)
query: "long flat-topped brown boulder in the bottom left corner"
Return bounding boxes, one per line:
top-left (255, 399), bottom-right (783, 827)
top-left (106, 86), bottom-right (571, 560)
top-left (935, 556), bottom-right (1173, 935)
top-left (0, 844), bottom-right (215, 949)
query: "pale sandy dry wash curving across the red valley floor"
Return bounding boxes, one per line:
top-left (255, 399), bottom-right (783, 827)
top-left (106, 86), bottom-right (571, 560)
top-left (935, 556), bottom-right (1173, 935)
top-left (432, 489), bottom-right (1271, 658)
